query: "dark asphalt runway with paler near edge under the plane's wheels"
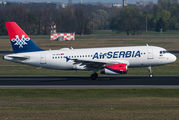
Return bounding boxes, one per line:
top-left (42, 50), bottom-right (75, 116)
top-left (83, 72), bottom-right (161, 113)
top-left (0, 76), bottom-right (179, 89)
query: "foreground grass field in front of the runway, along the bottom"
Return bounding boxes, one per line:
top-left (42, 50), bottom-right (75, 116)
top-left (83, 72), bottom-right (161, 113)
top-left (0, 89), bottom-right (179, 120)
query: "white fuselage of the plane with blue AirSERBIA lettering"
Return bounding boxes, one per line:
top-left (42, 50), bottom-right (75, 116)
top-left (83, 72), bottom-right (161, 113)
top-left (4, 46), bottom-right (176, 70)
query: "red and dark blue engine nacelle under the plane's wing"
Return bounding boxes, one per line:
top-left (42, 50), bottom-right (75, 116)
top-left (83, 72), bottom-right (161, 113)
top-left (101, 64), bottom-right (128, 75)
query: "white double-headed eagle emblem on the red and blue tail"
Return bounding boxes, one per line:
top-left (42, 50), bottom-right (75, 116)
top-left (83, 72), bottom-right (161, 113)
top-left (11, 35), bottom-right (30, 48)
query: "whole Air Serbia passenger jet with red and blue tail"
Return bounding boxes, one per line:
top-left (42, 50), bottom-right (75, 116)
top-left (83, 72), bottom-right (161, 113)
top-left (4, 22), bottom-right (176, 80)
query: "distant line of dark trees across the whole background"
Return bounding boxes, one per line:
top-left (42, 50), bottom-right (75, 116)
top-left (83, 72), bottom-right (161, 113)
top-left (0, 0), bottom-right (179, 35)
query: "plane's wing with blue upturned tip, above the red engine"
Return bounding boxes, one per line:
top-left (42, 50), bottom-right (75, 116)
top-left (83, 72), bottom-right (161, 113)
top-left (68, 59), bottom-right (129, 68)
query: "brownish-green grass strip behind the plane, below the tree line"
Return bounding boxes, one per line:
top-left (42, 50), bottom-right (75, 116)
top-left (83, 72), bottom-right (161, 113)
top-left (0, 34), bottom-right (179, 51)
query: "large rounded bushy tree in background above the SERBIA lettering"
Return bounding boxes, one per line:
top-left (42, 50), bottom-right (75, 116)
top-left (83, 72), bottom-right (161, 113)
top-left (110, 6), bottom-right (145, 35)
